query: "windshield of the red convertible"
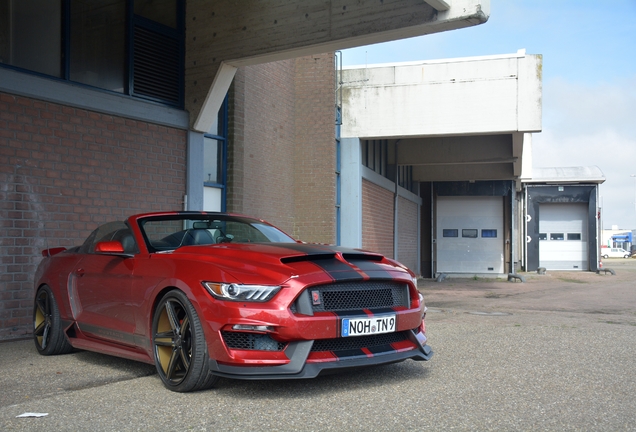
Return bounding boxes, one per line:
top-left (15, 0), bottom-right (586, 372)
top-left (139, 214), bottom-right (295, 252)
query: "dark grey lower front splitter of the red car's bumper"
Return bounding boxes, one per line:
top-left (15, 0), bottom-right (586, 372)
top-left (209, 330), bottom-right (433, 380)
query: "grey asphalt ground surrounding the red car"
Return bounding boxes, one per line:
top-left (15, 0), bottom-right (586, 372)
top-left (0, 259), bottom-right (636, 431)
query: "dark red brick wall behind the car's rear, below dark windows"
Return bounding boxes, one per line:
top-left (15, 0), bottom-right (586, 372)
top-left (0, 93), bottom-right (186, 339)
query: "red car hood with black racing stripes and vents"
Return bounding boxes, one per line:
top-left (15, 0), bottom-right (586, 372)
top-left (172, 243), bottom-right (412, 284)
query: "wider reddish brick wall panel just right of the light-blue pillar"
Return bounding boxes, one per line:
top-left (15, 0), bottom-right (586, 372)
top-left (362, 179), bottom-right (393, 258)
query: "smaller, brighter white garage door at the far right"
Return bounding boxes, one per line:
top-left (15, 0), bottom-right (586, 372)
top-left (539, 203), bottom-right (589, 270)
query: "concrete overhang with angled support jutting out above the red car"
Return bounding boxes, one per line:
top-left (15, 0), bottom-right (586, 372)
top-left (185, 0), bottom-right (490, 132)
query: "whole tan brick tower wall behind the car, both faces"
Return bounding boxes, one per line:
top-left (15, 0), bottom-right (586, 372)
top-left (227, 54), bottom-right (336, 243)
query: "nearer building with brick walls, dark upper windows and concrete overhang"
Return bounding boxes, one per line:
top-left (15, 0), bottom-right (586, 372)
top-left (0, 0), bottom-right (490, 339)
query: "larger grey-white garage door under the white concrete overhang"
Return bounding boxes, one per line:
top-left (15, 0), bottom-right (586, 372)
top-left (436, 197), bottom-right (504, 274)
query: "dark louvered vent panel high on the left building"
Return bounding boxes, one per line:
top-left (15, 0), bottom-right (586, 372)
top-left (132, 25), bottom-right (181, 105)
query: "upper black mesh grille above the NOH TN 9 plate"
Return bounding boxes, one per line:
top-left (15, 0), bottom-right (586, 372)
top-left (291, 281), bottom-right (410, 313)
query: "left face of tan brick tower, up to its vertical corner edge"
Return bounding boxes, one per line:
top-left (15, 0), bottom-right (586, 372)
top-left (227, 60), bottom-right (295, 234)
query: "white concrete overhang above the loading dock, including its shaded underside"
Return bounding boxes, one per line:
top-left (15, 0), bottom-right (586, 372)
top-left (341, 50), bottom-right (542, 185)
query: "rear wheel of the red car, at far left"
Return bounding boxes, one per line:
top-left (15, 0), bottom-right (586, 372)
top-left (33, 285), bottom-right (73, 355)
